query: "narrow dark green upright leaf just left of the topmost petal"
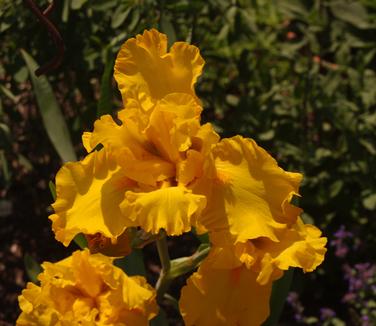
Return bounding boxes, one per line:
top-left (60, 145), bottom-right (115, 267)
top-left (97, 50), bottom-right (115, 117)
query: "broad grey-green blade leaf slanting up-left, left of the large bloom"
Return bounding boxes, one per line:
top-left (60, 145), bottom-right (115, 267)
top-left (21, 50), bottom-right (76, 162)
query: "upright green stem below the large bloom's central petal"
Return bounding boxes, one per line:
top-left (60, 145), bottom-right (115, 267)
top-left (155, 230), bottom-right (172, 302)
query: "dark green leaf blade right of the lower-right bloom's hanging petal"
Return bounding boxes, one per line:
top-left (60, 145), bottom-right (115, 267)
top-left (263, 268), bottom-right (294, 326)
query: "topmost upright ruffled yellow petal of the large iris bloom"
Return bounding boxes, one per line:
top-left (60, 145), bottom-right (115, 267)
top-left (114, 29), bottom-right (204, 103)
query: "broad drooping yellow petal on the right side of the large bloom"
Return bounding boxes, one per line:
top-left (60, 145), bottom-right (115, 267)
top-left (199, 136), bottom-right (302, 242)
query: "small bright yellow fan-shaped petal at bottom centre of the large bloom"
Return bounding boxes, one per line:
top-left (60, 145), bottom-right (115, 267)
top-left (120, 187), bottom-right (206, 235)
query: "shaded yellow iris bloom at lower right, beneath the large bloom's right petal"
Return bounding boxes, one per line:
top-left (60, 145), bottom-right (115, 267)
top-left (180, 218), bottom-right (326, 326)
